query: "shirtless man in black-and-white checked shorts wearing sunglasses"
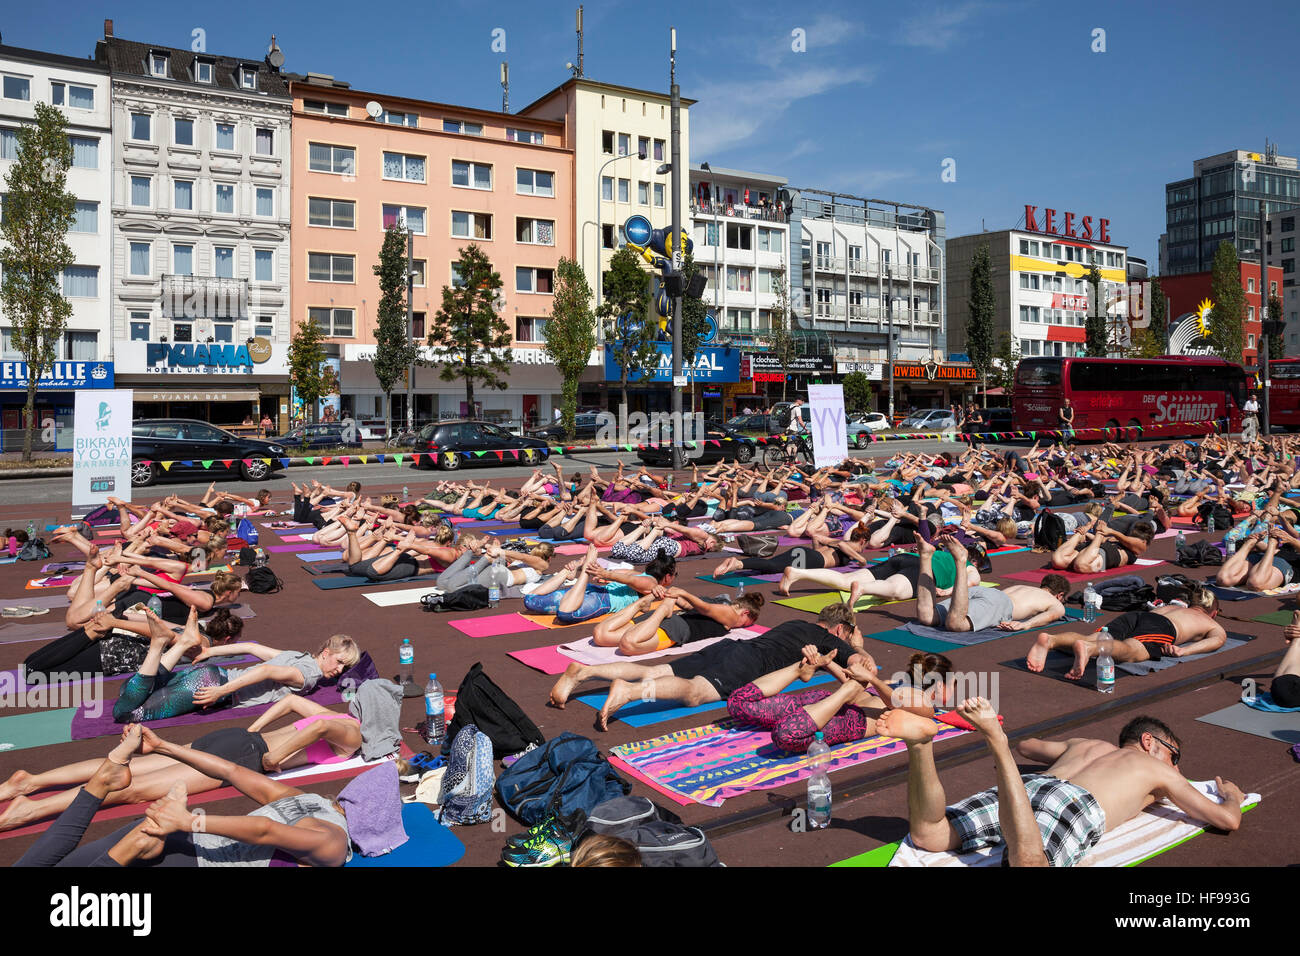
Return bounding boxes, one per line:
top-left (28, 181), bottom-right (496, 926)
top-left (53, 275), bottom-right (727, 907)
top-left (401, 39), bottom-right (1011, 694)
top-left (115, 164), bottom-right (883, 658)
top-left (876, 697), bottom-right (1243, 866)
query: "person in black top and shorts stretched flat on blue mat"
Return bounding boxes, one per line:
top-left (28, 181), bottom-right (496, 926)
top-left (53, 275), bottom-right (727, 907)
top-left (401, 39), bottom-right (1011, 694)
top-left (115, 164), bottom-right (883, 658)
top-left (549, 604), bottom-right (866, 730)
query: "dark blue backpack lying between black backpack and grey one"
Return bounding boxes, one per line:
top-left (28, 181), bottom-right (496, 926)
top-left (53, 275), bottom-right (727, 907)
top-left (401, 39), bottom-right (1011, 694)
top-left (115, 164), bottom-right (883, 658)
top-left (493, 738), bottom-right (632, 826)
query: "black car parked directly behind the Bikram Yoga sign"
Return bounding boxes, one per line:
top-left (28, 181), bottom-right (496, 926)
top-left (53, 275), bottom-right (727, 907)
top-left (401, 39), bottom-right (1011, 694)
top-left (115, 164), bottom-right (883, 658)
top-left (131, 419), bottom-right (286, 488)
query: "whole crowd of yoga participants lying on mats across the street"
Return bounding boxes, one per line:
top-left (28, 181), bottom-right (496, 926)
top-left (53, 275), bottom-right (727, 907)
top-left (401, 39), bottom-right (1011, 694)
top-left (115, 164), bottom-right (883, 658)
top-left (10, 433), bottom-right (1300, 866)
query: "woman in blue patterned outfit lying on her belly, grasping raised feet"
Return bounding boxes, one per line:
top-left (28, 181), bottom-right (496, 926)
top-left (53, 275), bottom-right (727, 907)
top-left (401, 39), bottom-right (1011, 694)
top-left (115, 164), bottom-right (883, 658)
top-left (524, 545), bottom-right (677, 624)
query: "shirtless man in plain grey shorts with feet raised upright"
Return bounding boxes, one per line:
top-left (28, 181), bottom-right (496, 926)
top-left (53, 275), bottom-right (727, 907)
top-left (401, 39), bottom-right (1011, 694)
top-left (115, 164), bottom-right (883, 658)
top-left (917, 535), bottom-right (1070, 632)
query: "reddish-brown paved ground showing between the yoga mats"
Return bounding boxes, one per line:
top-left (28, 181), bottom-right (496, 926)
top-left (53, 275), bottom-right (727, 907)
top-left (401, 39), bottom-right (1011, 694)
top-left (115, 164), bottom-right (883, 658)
top-left (0, 460), bottom-right (1300, 868)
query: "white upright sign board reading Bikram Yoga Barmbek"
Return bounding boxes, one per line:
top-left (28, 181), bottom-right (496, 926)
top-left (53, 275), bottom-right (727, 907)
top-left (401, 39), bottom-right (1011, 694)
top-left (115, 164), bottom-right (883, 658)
top-left (73, 389), bottom-right (134, 506)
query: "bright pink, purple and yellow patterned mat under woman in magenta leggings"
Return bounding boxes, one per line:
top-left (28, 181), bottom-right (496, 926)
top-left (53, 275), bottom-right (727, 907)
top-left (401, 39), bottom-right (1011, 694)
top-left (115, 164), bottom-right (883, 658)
top-left (610, 718), bottom-right (969, 806)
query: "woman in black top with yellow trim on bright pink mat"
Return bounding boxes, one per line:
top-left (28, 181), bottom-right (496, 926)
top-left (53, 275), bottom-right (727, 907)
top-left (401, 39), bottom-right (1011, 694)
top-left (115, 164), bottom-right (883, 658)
top-left (592, 588), bottom-right (763, 657)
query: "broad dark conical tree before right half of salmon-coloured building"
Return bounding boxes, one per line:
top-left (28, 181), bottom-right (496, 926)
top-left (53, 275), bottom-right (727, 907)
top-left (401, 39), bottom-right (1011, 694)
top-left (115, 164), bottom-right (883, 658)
top-left (429, 243), bottom-right (512, 414)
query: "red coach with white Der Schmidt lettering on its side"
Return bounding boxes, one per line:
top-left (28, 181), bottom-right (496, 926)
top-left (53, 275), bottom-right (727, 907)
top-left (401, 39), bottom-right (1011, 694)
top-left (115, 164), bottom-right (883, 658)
top-left (1011, 356), bottom-right (1245, 436)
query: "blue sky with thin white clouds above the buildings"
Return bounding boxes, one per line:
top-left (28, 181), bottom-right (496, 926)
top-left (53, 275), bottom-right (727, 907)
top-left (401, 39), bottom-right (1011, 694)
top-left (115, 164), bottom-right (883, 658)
top-left (0, 0), bottom-right (1300, 267)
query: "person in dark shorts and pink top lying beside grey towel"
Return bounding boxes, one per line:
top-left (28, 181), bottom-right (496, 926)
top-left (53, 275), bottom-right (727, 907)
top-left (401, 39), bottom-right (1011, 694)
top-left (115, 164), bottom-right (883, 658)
top-left (0, 693), bottom-right (361, 831)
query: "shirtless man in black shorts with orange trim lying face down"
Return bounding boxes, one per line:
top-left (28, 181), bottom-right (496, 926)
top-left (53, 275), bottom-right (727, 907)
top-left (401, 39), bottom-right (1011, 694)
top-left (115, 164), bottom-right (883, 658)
top-left (1024, 588), bottom-right (1227, 680)
